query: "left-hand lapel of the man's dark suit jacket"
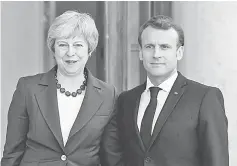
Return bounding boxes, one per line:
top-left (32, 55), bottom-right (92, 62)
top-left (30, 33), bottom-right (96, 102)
top-left (130, 82), bottom-right (146, 151)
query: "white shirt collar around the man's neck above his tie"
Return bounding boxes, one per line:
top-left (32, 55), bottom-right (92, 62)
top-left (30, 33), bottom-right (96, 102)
top-left (145, 71), bottom-right (178, 92)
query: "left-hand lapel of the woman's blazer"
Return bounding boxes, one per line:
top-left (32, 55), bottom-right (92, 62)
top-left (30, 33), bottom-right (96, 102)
top-left (35, 67), bottom-right (63, 149)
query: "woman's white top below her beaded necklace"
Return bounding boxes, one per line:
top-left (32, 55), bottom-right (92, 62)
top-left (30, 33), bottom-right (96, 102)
top-left (57, 90), bottom-right (86, 145)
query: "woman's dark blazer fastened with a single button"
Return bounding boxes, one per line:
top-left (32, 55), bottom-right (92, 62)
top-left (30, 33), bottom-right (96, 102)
top-left (1, 68), bottom-right (123, 166)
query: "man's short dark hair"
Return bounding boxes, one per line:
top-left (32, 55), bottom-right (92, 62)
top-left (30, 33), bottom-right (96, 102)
top-left (138, 15), bottom-right (184, 47)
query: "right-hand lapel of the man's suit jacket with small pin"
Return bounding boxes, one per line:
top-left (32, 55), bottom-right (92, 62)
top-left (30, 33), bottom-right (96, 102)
top-left (148, 72), bottom-right (187, 149)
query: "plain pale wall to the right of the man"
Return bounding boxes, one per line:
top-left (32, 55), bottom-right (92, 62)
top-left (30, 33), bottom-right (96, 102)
top-left (172, 2), bottom-right (237, 166)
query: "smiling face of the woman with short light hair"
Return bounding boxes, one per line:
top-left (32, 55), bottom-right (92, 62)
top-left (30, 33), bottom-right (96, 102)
top-left (54, 36), bottom-right (89, 76)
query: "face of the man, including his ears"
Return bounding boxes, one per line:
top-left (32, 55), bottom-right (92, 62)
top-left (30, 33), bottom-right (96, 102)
top-left (139, 27), bottom-right (183, 79)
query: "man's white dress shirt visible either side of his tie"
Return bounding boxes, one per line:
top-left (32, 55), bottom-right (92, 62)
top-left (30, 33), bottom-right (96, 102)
top-left (137, 72), bottom-right (178, 134)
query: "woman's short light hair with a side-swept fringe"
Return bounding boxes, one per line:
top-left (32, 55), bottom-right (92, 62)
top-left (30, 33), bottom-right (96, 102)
top-left (47, 11), bottom-right (99, 53)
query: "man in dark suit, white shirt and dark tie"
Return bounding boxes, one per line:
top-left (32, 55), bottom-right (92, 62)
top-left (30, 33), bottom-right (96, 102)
top-left (117, 16), bottom-right (229, 166)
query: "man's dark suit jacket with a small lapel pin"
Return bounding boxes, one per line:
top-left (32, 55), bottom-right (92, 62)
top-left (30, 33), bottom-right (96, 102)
top-left (118, 73), bottom-right (229, 166)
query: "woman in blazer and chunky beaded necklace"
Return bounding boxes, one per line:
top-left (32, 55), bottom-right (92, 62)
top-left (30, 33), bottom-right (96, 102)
top-left (1, 11), bottom-right (121, 166)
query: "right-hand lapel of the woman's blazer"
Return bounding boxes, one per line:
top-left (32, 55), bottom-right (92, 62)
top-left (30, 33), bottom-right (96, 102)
top-left (66, 71), bottom-right (103, 143)
